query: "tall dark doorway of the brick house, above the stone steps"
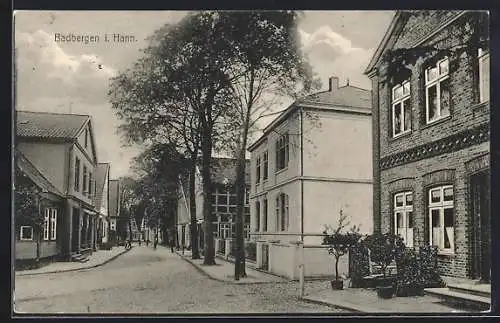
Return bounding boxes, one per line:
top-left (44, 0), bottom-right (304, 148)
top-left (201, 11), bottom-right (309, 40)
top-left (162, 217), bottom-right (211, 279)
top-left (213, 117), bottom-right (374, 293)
top-left (470, 170), bottom-right (491, 283)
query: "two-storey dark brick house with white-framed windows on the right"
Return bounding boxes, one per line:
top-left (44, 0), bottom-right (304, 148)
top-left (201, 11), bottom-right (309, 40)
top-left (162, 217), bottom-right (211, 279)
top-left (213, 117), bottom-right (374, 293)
top-left (365, 11), bottom-right (491, 281)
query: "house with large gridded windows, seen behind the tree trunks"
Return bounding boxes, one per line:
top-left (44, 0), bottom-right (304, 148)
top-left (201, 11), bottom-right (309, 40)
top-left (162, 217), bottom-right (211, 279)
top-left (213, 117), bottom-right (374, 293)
top-left (176, 157), bottom-right (250, 252)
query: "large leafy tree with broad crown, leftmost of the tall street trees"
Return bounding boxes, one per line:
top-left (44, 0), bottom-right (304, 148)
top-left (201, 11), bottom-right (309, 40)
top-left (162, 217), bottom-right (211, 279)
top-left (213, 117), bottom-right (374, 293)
top-left (110, 12), bottom-right (243, 264)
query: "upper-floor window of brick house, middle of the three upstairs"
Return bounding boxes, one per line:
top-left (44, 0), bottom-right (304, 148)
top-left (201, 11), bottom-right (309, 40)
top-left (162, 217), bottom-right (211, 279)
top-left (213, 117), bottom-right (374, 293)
top-left (425, 58), bottom-right (451, 123)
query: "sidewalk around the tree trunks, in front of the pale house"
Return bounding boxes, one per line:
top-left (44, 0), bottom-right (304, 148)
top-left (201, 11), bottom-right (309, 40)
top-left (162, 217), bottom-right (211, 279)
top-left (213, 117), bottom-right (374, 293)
top-left (176, 250), bottom-right (289, 284)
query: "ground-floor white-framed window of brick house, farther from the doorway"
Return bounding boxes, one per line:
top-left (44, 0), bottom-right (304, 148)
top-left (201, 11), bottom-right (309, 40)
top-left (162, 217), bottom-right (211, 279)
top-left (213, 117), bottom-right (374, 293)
top-left (394, 192), bottom-right (413, 247)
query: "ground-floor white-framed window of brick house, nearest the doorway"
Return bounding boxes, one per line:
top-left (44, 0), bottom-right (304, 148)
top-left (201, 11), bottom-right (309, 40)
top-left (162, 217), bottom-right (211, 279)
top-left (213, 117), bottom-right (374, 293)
top-left (429, 185), bottom-right (455, 253)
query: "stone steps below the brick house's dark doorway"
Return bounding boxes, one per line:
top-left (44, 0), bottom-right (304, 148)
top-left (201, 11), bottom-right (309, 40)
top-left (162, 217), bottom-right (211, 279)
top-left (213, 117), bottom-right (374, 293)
top-left (424, 287), bottom-right (491, 311)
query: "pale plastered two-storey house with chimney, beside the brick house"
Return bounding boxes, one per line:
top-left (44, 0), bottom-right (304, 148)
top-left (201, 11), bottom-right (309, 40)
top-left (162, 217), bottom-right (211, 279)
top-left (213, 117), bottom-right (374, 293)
top-left (248, 77), bottom-right (372, 279)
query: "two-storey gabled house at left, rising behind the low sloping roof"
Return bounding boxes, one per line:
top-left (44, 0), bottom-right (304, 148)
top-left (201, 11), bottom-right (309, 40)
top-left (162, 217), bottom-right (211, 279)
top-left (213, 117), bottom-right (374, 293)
top-left (15, 111), bottom-right (97, 259)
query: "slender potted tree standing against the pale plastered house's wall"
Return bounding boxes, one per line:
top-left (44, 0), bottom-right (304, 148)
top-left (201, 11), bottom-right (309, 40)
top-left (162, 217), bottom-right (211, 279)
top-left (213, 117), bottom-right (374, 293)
top-left (322, 210), bottom-right (361, 290)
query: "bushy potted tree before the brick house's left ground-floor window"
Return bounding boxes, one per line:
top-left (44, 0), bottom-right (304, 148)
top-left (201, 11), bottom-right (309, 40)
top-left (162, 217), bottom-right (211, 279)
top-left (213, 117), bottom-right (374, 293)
top-left (363, 233), bottom-right (406, 298)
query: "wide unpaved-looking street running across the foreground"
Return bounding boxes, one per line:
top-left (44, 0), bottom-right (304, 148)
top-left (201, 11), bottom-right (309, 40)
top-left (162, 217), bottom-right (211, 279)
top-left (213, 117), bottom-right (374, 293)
top-left (14, 245), bottom-right (342, 314)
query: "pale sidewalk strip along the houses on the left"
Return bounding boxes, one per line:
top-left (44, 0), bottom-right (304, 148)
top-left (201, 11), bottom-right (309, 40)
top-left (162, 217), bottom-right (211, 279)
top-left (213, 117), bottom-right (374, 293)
top-left (16, 246), bottom-right (128, 276)
